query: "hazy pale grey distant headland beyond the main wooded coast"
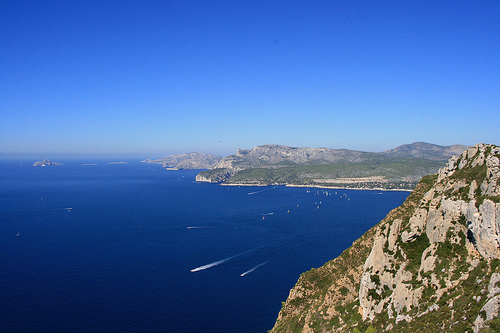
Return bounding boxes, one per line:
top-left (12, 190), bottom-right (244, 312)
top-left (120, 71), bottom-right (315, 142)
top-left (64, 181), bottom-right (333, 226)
top-left (142, 153), bottom-right (222, 170)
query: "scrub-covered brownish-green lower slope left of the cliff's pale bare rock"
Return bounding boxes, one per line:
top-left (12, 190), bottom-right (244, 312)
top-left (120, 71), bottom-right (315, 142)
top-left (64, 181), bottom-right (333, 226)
top-left (271, 175), bottom-right (437, 332)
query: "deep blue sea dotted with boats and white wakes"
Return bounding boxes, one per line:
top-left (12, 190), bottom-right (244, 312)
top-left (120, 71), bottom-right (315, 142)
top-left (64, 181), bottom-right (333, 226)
top-left (0, 161), bottom-right (408, 333)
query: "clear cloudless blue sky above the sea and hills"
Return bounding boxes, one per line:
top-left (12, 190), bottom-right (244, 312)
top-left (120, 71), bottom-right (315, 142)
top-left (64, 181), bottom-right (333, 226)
top-left (0, 0), bottom-right (500, 158)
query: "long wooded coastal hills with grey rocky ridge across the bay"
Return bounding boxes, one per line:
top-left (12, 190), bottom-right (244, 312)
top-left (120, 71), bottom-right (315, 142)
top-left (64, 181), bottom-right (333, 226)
top-left (196, 143), bottom-right (466, 189)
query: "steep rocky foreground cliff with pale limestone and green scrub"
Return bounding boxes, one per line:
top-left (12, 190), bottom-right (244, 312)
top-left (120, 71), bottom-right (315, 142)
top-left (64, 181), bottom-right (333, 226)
top-left (271, 144), bottom-right (500, 333)
